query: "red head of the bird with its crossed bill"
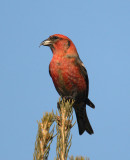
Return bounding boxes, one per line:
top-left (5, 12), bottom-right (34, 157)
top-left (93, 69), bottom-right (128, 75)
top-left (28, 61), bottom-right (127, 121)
top-left (40, 34), bottom-right (77, 55)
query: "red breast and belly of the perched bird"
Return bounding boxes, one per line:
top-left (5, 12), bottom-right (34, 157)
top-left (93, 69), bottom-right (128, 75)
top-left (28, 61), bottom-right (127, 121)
top-left (49, 55), bottom-right (87, 96)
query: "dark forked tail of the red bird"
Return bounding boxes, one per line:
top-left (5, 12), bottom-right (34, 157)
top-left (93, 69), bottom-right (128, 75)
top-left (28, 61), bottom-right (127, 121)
top-left (74, 104), bottom-right (94, 135)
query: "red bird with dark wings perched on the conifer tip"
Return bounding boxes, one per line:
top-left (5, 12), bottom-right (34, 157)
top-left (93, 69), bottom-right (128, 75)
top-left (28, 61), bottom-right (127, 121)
top-left (40, 34), bottom-right (95, 135)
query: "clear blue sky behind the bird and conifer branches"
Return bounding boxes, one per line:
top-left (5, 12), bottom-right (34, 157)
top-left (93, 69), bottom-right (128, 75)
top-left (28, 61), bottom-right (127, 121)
top-left (0, 0), bottom-right (130, 160)
